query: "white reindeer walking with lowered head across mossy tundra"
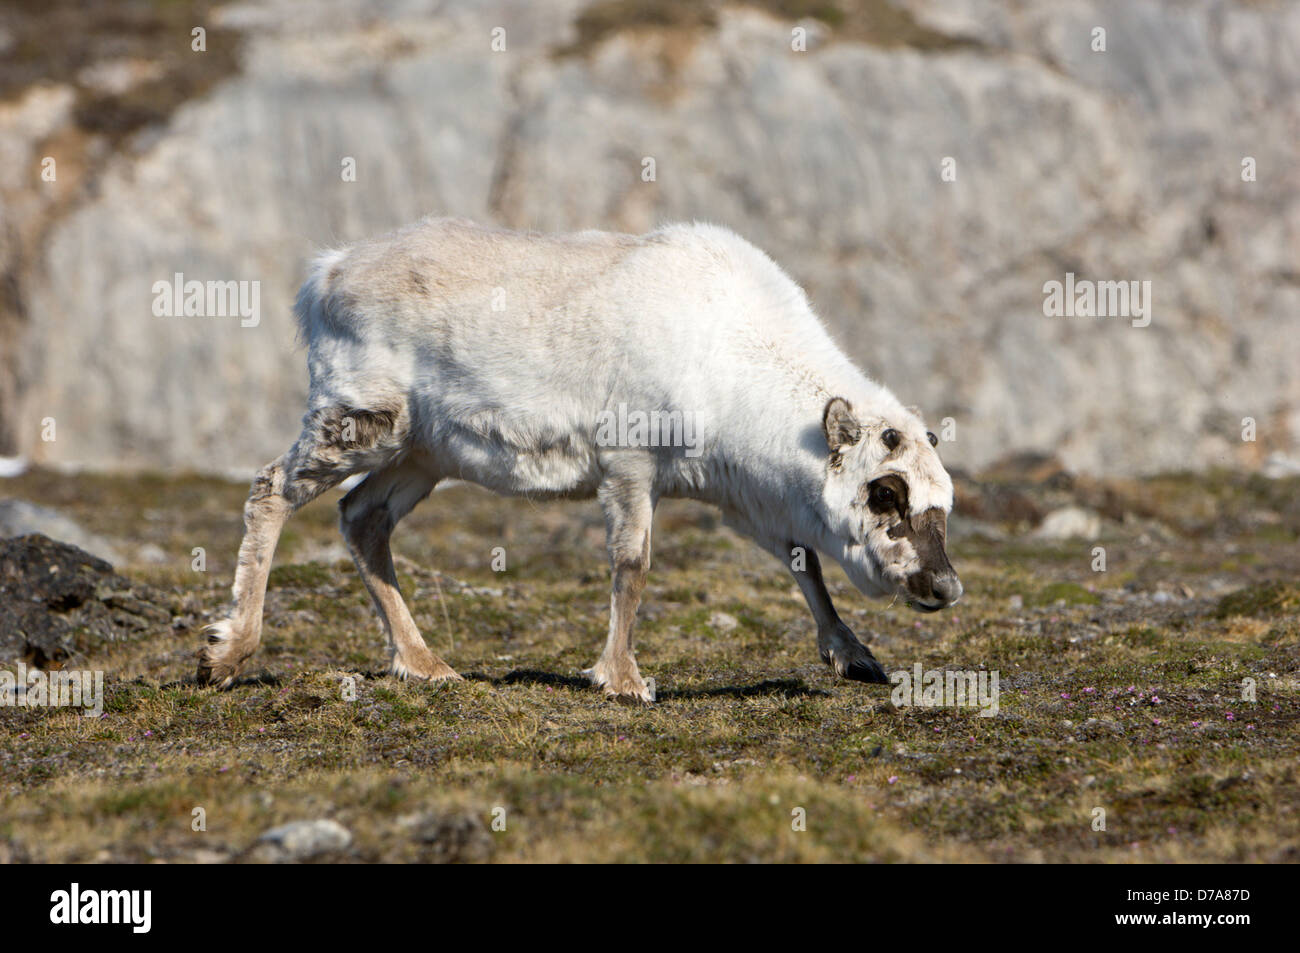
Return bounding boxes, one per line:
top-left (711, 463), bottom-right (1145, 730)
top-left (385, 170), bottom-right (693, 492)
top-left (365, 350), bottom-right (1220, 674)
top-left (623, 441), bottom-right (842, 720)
top-left (198, 218), bottom-right (962, 701)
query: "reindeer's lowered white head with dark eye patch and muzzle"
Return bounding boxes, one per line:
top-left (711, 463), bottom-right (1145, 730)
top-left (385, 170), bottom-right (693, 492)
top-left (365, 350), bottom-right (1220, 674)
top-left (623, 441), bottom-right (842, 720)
top-left (822, 398), bottom-right (962, 612)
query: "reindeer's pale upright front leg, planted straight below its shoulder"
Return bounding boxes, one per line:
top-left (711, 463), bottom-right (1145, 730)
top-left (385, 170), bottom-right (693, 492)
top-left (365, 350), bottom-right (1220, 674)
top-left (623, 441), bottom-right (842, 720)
top-left (582, 460), bottom-right (655, 705)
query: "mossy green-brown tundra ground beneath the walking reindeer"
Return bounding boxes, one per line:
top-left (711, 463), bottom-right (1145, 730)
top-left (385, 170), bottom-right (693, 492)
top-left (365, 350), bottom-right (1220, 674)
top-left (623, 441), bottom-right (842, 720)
top-left (0, 472), bottom-right (1300, 862)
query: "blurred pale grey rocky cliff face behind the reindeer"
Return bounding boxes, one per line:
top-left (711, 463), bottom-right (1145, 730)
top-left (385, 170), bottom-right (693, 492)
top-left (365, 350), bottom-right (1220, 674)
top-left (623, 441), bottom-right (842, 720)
top-left (0, 0), bottom-right (1300, 472)
